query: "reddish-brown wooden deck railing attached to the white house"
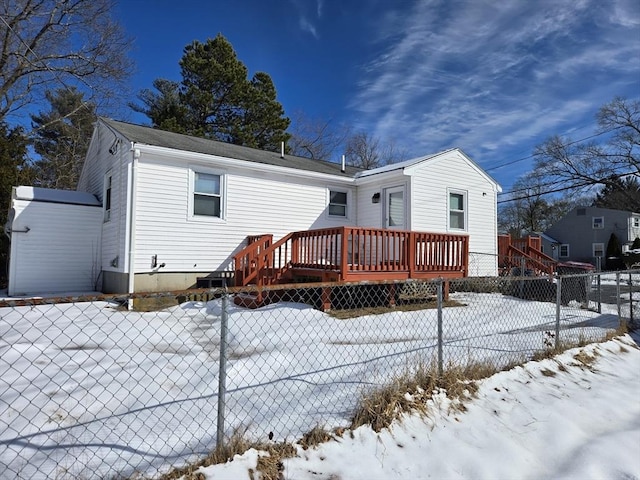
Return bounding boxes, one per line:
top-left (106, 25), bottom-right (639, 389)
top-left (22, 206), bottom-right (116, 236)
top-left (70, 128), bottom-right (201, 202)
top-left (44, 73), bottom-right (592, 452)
top-left (234, 227), bottom-right (469, 286)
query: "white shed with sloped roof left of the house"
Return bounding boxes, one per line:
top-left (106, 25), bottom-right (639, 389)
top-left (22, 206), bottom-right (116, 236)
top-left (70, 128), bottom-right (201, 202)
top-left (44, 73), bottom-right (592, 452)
top-left (5, 186), bottom-right (103, 296)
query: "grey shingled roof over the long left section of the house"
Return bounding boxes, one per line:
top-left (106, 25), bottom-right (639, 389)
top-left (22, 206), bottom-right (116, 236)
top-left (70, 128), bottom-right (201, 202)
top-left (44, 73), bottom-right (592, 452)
top-left (99, 117), bottom-right (362, 178)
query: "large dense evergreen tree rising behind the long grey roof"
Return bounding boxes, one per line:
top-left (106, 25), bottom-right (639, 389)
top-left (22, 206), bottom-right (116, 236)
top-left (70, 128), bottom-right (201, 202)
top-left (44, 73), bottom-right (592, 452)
top-left (131, 34), bottom-right (289, 151)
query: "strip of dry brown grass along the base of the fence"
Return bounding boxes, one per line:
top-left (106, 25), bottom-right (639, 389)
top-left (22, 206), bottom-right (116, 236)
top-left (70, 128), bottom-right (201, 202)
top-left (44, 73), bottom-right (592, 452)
top-left (155, 330), bottom-right (627, 480)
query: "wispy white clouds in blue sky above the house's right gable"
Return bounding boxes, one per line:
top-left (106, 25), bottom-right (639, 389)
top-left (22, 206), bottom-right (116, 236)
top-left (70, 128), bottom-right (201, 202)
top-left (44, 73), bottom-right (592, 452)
top-left (350, 0), bottom-right (640, 171)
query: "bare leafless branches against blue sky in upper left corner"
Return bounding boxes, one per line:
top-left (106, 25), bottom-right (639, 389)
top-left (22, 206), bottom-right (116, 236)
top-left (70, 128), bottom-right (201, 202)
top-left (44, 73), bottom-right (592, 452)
top-left (0, 0), bottom-right (131, 120)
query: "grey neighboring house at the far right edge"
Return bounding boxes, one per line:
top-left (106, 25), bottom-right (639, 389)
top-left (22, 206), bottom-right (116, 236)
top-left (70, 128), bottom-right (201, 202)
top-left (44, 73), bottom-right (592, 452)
top-left (542, 207), bottom-right (640, 268)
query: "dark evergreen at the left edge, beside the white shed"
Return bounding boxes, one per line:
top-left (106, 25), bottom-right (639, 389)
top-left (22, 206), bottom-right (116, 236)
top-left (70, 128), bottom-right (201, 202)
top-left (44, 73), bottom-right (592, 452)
top-left (0, 122), bottom-right (33, 288)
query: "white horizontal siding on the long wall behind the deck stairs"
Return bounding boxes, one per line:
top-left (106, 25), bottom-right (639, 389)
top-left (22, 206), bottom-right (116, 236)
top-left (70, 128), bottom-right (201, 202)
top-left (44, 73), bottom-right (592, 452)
top-left (135, 152), bottom-right (355, 289)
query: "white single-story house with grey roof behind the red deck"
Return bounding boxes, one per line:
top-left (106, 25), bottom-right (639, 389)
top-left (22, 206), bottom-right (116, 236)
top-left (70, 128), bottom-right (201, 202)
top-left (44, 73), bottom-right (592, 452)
top-left (7, 118), bottom-right (501, 293)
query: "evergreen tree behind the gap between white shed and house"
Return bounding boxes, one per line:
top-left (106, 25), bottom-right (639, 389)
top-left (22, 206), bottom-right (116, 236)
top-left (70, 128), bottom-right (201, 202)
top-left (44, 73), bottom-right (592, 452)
top-left (31, 88), bottom-right (96, 190)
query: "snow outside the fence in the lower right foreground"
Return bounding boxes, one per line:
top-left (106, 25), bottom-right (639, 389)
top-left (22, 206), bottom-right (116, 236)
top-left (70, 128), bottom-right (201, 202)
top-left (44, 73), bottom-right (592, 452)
top-left (206, 335), bottom-right (640, 480)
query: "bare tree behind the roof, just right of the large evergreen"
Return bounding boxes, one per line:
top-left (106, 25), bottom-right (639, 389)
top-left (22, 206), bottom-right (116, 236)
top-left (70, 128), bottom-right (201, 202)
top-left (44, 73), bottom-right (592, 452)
top-left (287, 111), bottom-right (350, 160)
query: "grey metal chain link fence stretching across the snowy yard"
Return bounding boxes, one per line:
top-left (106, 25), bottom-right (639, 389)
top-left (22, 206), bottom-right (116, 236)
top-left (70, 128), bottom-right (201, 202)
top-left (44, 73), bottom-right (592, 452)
top-left (0, 271), bottom-right (640, 479)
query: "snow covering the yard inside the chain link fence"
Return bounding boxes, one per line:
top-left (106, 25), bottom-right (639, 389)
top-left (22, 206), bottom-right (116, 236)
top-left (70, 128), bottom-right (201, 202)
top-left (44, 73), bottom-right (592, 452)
top-left (0, 280), bottom-right (640, 479)
